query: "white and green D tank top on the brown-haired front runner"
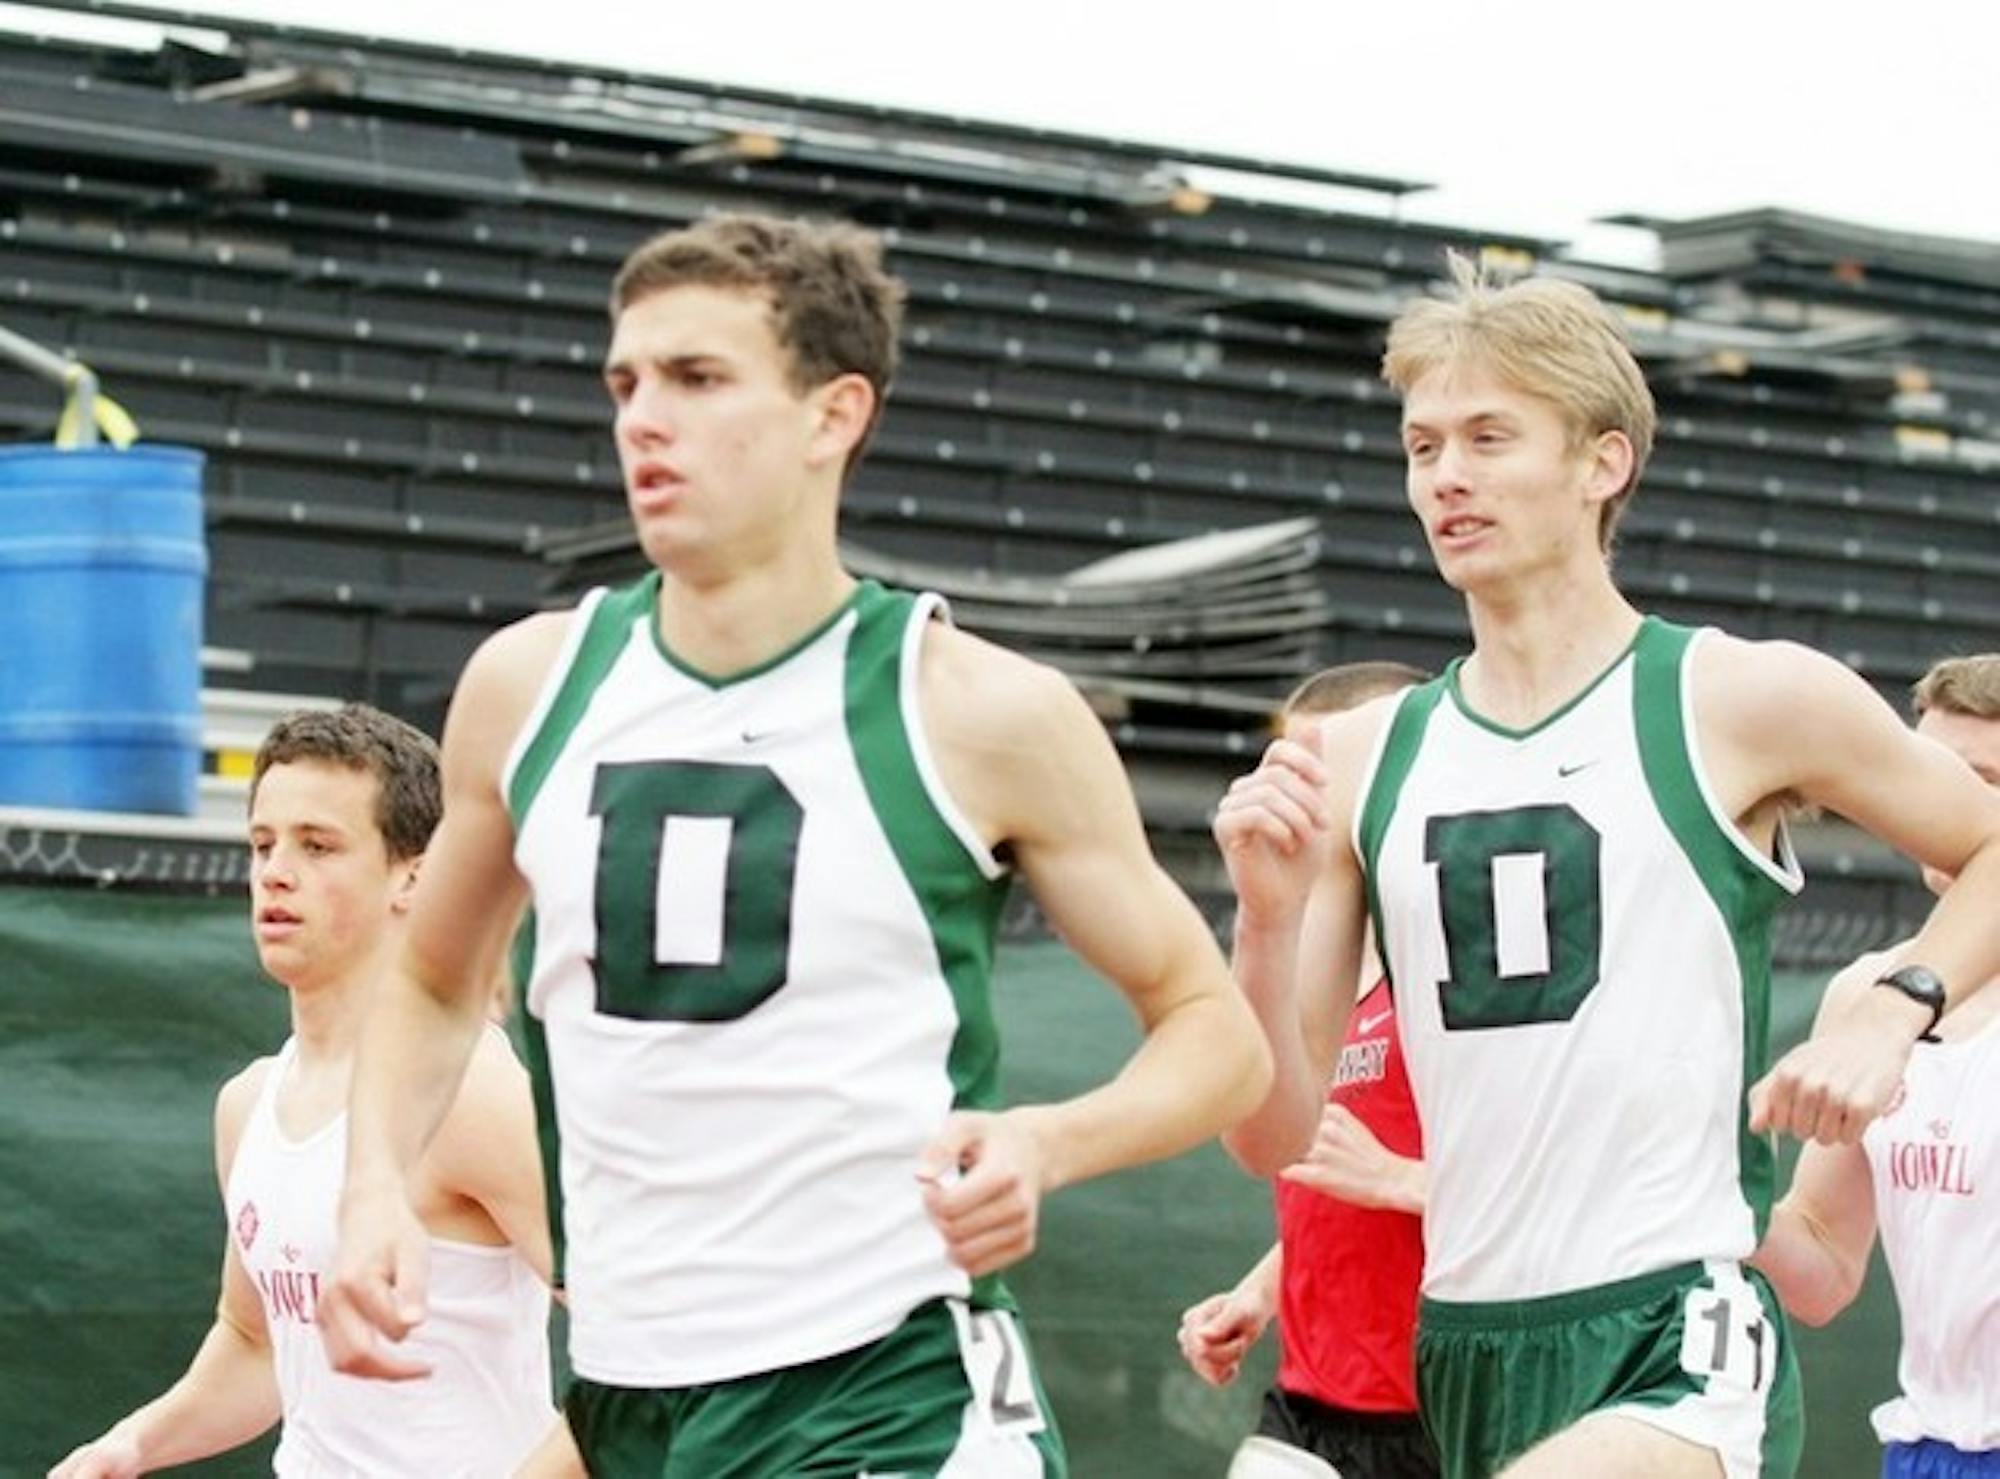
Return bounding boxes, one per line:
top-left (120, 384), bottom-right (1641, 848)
top-left (504, 576), bottom-right (1006, 1387)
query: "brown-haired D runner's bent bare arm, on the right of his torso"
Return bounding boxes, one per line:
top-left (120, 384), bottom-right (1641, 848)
top-left (924, 630), bottom-right (1270, 1271)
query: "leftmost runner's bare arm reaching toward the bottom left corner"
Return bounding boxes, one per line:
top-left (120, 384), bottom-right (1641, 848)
top-left (50, 1065), bottom-right (282, 1479)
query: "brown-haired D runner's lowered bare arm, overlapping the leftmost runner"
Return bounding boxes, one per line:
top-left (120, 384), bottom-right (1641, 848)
top-left (320, 614), bottom-right (570, 1379)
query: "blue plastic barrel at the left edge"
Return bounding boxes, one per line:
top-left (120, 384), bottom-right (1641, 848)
top-left (0, 446), bottom-right (208, 815)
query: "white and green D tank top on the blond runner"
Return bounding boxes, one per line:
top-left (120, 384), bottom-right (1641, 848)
top-left (1354, 618), bottom-right (1802, 1301)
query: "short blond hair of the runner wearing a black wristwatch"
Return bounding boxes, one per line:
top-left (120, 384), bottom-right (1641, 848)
top-left (1382, 252), bottom-right (1660, 550)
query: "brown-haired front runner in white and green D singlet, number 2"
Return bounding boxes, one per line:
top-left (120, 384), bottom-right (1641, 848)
top-left (324, 216), bottom-right (1268, 1479)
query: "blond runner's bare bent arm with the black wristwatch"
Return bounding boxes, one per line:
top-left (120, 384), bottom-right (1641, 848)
top-left (1696, 640), bottom-right (2000, 1143)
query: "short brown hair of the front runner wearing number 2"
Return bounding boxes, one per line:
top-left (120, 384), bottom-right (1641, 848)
top-left (612, 214), bottom-right (904, 470)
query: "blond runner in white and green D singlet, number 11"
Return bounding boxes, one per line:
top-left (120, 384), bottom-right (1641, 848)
top-left (1216, 260), bottom-right (2000, 1479)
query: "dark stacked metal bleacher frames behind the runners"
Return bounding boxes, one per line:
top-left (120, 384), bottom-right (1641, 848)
top-left (0, 0), bottom-right (2000, 957)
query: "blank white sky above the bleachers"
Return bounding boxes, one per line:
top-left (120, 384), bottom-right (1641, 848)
top-left (0, 0), bottom-right (2000, 260)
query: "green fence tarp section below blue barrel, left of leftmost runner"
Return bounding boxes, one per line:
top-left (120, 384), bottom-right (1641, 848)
top-left (0, 887), bottom-right (286, 1479)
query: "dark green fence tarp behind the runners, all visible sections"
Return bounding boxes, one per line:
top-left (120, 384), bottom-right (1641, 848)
top-left (0, 887), bottom-right (1896, 1479)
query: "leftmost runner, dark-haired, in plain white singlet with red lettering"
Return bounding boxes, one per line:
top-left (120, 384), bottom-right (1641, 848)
top-left (52, 704), bottom-right (562, 1479)
